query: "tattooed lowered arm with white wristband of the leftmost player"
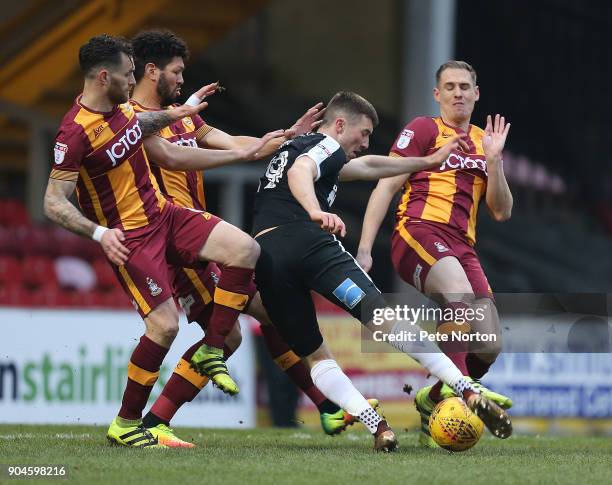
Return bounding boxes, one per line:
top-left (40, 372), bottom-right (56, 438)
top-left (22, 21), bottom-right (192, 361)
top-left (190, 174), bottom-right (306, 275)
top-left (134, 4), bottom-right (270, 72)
top-left (44, 178), bottom-right (129, 265)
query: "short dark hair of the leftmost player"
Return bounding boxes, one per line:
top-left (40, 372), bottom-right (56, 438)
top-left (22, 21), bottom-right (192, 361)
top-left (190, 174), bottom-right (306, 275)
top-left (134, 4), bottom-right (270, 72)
top-left (79, 34), bottom-right (133, 77)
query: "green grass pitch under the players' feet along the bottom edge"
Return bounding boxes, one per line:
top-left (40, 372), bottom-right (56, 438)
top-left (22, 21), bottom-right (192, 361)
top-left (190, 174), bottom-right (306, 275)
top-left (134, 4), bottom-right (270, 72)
top-left (0, 425), bottom-right (612, 485)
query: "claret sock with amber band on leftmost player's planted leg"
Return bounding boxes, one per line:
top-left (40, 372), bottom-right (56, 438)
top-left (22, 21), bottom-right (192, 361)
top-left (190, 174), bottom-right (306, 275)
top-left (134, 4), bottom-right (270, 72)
top-left (119, 335), bottom-right (168, 419)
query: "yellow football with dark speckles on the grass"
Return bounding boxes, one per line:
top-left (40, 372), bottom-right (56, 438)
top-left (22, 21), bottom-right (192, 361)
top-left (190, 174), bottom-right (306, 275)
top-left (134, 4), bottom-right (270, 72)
top-left (429, 397), bottom-right (484, 451)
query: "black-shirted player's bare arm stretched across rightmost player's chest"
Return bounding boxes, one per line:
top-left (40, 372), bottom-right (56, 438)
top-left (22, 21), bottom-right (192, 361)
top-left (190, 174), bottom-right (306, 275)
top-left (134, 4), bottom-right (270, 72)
top-left (340, 136), bottom-right (460, 181)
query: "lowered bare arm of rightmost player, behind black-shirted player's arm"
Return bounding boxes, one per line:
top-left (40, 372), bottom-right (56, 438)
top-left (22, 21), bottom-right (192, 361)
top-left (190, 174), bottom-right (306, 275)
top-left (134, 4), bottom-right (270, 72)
top-left (357, 174), bottom-right (408, 271)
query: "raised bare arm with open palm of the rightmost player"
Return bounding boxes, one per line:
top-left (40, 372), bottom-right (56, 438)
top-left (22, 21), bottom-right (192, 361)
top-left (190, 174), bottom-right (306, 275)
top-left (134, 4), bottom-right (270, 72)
top-left (482, 114), bottom-right (514, 222)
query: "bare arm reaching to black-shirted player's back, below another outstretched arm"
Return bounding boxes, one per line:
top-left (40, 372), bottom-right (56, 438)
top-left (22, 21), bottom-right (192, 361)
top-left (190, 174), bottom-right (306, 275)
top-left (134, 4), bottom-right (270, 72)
top-left (144, 130), bottom-right (283, 171)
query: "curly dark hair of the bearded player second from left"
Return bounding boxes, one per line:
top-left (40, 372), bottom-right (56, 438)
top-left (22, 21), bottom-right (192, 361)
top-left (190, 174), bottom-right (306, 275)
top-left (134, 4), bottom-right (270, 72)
top-left (132, 29), bottom-right (189, 81)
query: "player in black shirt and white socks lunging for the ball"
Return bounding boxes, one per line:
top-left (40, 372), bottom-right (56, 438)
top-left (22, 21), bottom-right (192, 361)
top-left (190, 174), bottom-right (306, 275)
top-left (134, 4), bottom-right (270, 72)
top-left (253, 92), bottom-right (512, 451)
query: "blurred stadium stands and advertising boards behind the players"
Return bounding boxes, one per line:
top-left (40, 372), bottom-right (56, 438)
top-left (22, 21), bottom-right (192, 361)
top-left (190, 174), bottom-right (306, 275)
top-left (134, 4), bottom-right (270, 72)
top-left (0, 0), bottom-right (612, 433)
